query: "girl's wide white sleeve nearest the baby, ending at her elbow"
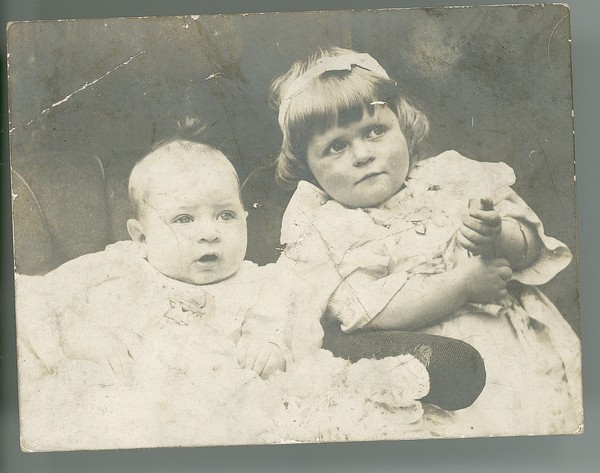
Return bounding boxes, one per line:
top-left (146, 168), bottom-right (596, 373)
top-left (278, 183), bottom-right (407, 331)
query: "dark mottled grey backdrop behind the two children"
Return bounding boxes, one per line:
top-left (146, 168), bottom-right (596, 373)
top-left (7, 5), bottom-right (579, 332)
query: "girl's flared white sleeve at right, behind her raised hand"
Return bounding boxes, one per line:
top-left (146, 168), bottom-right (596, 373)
top-left (498, 191), bottom-right (573, 286)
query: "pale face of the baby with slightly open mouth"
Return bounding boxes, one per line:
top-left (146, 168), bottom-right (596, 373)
top-left (139, 151), bottom-right (247, 284)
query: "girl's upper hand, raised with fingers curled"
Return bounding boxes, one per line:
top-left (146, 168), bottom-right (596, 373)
top-left (458, 199), bottom-right (502, 258)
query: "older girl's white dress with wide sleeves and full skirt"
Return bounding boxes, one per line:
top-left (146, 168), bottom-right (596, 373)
top-left (279, 151), bottom-right (582, 436)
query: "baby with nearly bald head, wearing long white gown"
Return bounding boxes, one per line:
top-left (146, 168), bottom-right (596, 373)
top-left (16, 139), bottom-right (288, 450)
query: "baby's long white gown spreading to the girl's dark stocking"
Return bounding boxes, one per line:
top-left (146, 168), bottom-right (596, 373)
top-left (16, 242), bottom-right (431, 451)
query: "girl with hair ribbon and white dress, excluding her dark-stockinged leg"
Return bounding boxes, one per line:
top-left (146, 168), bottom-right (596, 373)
top-left (272, 48), bottom-right (582, 435)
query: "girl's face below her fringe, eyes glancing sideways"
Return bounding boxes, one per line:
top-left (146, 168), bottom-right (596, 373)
top-left (306, 105), bottom-right (410, 208)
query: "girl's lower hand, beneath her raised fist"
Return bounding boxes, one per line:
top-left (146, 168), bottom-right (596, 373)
top-left (460, 257), bottom-right (512, 302)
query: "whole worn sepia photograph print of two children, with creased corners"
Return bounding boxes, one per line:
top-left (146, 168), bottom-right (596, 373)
top-left (7, 4), bottom-right (584, 452)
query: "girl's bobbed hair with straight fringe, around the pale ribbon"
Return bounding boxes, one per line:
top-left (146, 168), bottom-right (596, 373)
top-left (270, 47), bottom-right (429, 190)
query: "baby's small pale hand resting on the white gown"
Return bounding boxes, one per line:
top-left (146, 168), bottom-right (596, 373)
top-left (236, 337), bottom-right (286, 379)
